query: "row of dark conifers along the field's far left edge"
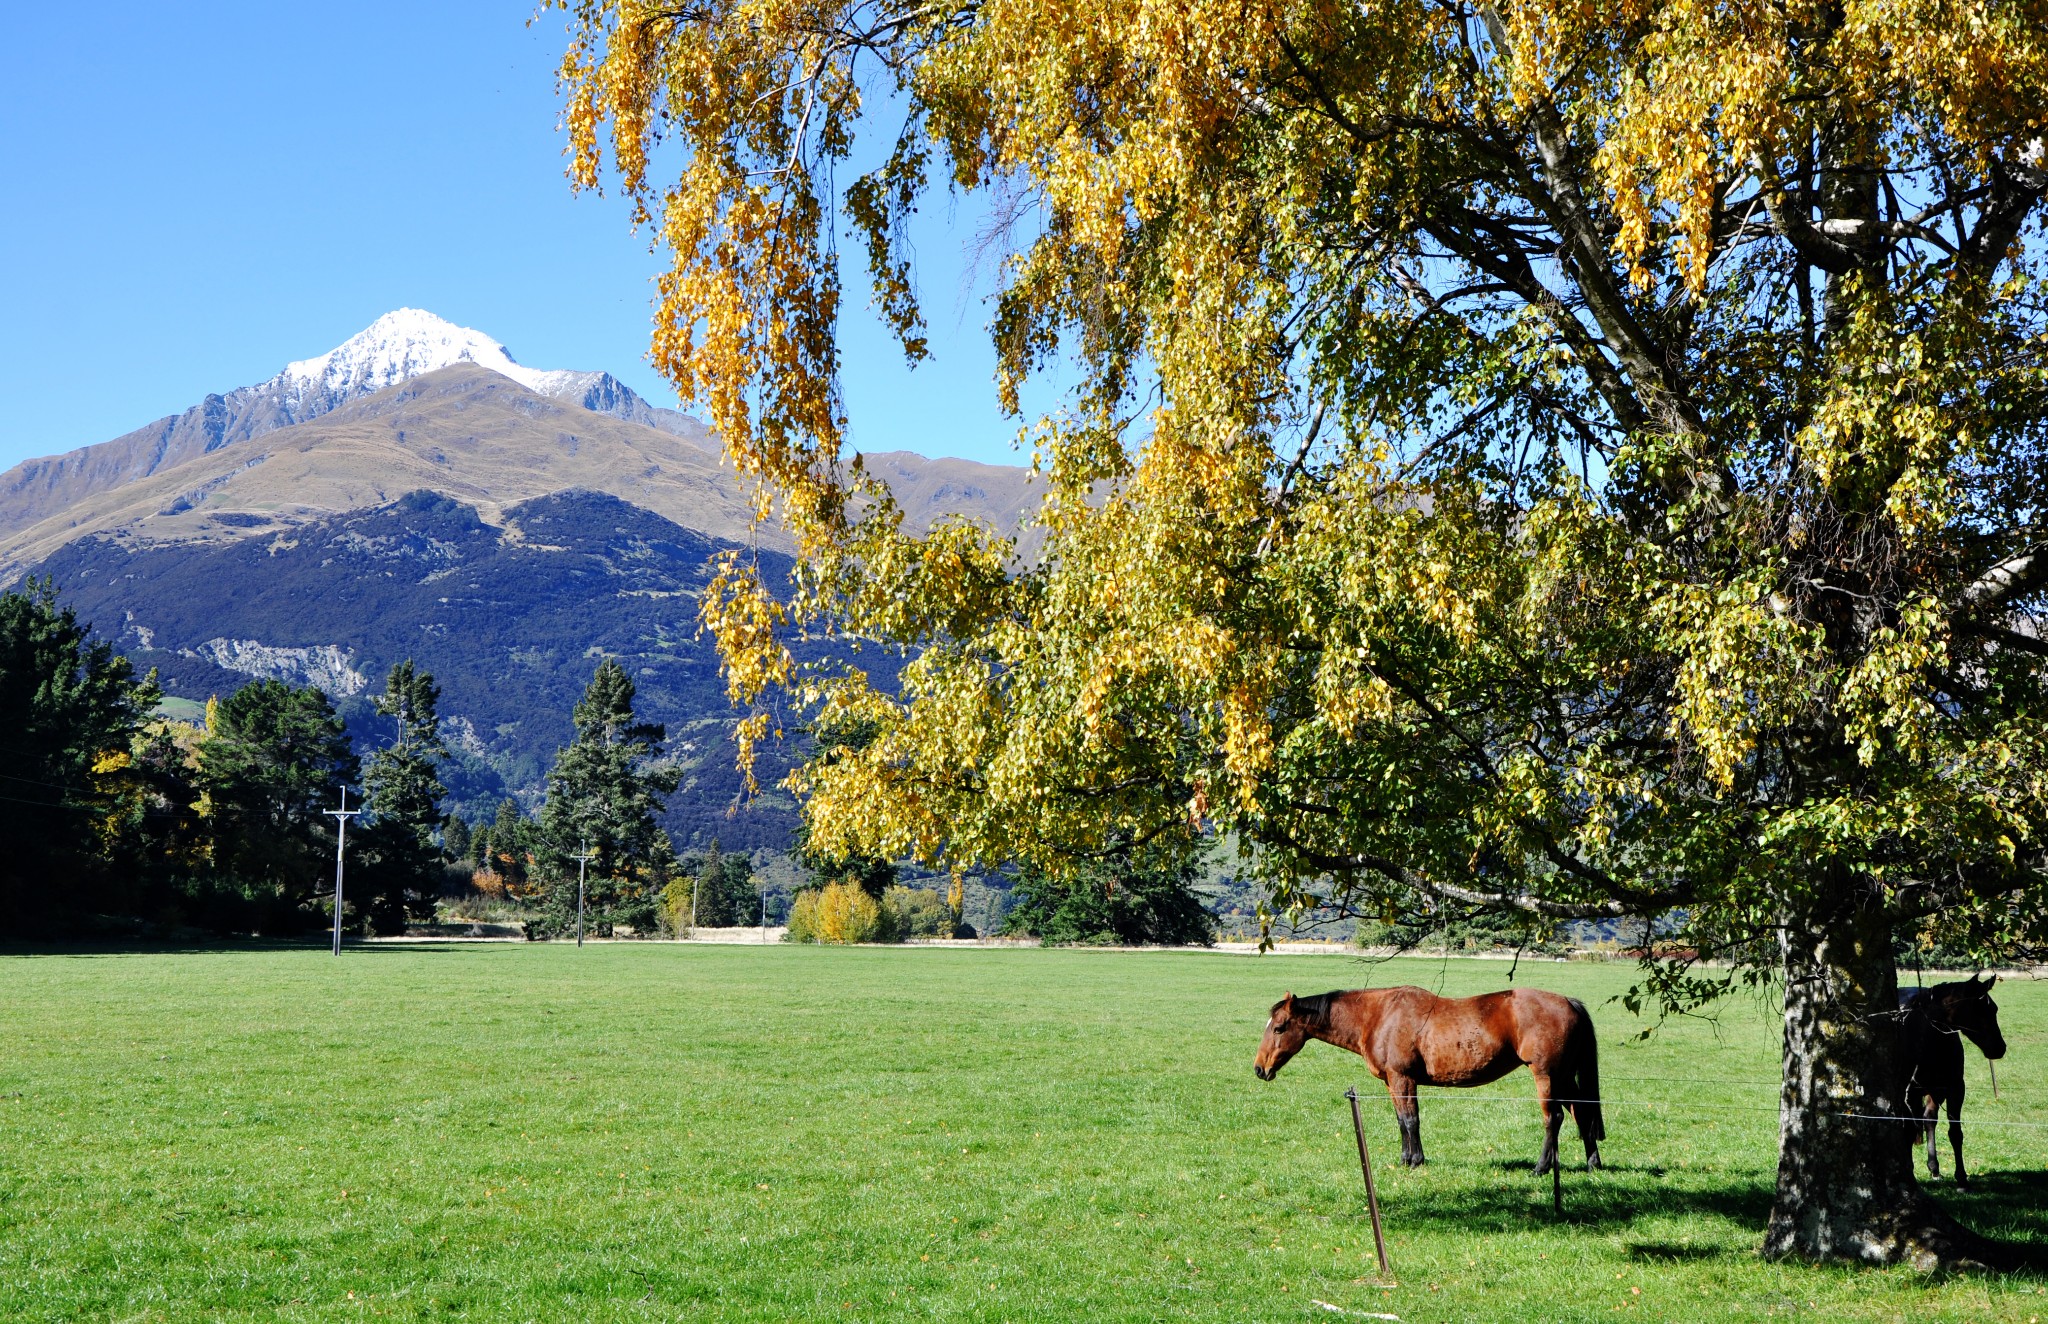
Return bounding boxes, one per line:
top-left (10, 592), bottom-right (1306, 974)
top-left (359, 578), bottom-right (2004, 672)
top-left (0, 580), bottom-right (692, 939)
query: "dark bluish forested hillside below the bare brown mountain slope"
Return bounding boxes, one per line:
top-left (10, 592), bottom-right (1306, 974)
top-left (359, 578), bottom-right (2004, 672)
top-left (35, 492), bottom-right (795, 851)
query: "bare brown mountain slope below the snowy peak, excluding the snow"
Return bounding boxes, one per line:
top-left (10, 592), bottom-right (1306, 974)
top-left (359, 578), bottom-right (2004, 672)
top-left (0, 363), bottom-right (1030, 580)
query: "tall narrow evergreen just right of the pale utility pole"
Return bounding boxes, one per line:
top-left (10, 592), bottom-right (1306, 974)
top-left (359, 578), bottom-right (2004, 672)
top-left (360, 658), bottom-right (449, 933)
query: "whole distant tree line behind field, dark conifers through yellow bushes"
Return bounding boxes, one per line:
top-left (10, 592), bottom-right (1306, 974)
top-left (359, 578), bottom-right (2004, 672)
top-left (0, 580), bottom-right (1214, 943)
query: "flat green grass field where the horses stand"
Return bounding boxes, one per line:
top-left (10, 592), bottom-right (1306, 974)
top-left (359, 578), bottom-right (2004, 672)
top-left (0, 945), bottom-right (2048, 1320)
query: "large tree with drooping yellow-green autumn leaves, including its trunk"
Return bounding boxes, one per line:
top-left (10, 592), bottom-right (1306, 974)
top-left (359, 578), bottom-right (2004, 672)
top-left (563, 0), bottom-right (2048, 1260)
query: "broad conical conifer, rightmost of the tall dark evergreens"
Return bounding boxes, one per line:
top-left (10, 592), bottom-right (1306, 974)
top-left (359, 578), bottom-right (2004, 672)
top-left (536, 658), bottom-right (682, 935)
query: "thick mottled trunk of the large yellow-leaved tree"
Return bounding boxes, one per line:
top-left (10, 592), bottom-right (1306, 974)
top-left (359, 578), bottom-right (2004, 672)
top-left (1763, 902), bottom-right (1993, 1269)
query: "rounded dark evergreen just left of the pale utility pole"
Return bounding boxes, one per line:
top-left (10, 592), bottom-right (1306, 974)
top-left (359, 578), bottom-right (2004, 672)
top-left (197, 680), bottom-right (356, 930)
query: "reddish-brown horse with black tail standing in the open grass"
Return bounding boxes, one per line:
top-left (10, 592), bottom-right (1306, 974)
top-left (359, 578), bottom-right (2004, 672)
top-left (1251, 988), bottom-right (1608, 1176)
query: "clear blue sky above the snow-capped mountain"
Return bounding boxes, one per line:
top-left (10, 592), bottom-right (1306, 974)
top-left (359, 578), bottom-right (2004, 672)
top-left (0, 0), bottom-right (1020, 469)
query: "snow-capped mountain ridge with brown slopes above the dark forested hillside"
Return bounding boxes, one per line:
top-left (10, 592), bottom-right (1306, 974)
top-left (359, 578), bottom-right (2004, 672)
top-left (0, 309), bottom-right (1034, 584)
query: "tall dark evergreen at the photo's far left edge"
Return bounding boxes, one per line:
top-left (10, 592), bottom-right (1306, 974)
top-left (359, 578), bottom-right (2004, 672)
top-left (0, 580), bottom-right (158, 935)
